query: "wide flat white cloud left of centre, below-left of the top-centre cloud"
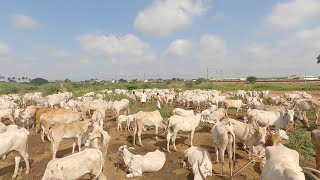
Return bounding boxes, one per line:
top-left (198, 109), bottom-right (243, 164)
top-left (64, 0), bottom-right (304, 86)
top-left (78, 34), bottom-right (155, 62)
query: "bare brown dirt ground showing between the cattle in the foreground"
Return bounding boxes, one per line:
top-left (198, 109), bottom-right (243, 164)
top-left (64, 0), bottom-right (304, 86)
top-left (0, 91), bottom-right (319, 180)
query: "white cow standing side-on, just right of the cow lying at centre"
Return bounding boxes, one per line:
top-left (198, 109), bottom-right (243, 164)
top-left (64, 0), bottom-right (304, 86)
top-left (167, 114), bottom-right (201, 152)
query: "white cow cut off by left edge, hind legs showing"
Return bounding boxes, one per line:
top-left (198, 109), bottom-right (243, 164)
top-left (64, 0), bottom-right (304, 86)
top-left (0, 127), bottom-right (30, 178)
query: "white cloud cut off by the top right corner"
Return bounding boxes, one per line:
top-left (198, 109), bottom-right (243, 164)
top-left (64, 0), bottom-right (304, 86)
top-left (265, 0), bottom-right (320, 29)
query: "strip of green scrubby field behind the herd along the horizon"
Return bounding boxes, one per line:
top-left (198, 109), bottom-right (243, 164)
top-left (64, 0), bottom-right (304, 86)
top-left (0, 80), bottom-right (320, 96)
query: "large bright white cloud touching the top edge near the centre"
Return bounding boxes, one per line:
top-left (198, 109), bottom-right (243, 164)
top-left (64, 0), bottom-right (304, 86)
top-left (134, 0), bottom-right (207, 36)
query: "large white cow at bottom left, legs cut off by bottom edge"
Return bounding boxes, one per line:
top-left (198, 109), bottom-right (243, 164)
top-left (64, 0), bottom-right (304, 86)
top-left (42, 149), bottom-right (107, 180)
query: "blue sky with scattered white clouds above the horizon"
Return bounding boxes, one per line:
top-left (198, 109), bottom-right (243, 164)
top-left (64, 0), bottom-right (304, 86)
top-left (0, 0), bottom-right (320, 80)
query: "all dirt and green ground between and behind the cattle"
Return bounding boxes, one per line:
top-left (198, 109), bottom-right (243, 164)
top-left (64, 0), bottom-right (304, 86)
top-left (0, 82), bottom-right (320, 180)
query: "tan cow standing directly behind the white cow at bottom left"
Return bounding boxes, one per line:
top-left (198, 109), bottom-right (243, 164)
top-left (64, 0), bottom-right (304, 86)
top-left (48, 119), bottom-right (92, 159)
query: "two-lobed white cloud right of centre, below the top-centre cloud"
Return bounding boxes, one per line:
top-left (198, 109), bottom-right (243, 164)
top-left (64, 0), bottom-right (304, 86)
top-left (164, 34), bottom-right (228, 61)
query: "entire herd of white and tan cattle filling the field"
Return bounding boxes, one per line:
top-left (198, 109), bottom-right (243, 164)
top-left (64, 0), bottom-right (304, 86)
top-left (0, 89), bottom-right (320, 180)
